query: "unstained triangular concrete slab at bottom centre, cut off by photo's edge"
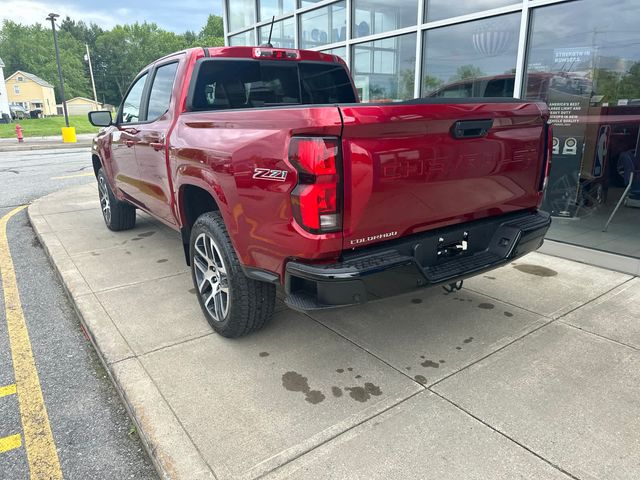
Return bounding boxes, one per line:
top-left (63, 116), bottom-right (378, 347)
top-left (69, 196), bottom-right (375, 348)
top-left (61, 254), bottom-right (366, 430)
top-left (267, 392), bottom-right (569, 480)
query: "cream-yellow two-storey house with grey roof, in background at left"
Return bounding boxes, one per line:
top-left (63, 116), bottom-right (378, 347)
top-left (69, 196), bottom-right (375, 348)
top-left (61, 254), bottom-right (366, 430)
top-left (6, 70), bottom-right (57, 115)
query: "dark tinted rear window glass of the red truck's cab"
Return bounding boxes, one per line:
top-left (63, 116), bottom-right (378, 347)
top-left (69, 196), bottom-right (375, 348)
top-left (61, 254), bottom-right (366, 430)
top-left (191, 59), bottom-right (356, 111)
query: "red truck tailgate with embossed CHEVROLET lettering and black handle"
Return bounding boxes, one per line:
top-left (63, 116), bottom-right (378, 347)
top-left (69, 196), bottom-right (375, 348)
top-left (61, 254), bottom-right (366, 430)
top-left (339, 99), bottom-right (548, 249)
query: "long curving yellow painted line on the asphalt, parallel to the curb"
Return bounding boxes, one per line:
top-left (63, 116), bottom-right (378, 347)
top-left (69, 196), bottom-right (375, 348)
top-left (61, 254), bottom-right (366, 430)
top-left (0, 205), bottom-right (62, 480)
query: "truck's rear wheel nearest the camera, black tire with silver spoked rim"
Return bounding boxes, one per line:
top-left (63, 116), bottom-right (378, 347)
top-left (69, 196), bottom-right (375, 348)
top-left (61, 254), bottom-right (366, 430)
top-left (189, 212), bottom-right (276, 338)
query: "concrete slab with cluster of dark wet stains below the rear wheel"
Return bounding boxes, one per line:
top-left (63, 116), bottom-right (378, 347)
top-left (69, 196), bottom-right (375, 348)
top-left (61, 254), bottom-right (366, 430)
top-left (141, 310), bottom-right (421, 478)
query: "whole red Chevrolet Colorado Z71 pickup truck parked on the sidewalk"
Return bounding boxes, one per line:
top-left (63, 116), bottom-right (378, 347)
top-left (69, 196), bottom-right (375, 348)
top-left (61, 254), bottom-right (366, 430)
top-left (89, 47), bottom-right (551, 337)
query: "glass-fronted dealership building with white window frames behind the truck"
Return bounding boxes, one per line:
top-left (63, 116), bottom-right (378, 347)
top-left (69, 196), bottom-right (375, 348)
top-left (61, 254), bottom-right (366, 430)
top-left (223, 0), bottom-right (640, 274)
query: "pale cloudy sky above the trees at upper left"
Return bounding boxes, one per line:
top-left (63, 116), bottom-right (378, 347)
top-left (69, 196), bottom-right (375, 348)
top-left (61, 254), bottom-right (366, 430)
top-left (0, 0), bottom-right (222, 33)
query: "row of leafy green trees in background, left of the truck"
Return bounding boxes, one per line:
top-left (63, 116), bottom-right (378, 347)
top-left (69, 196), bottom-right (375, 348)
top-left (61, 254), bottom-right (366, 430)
top-left (0, 15), bottom-right (224, 105)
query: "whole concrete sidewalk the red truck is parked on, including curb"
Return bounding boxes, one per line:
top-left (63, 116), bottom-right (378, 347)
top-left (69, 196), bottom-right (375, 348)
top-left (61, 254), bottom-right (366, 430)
top-left (29, 186), bottom-right (640, 480)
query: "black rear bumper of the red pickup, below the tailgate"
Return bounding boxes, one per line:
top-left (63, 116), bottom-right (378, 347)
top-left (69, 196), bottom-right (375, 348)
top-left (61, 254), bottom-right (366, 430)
top-left (285, 212), bottom-right (551, 310)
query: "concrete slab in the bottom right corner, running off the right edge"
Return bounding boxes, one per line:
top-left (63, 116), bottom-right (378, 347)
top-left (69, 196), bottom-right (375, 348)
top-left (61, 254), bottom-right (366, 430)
top-left (434, 323), bottom-right (640, 480)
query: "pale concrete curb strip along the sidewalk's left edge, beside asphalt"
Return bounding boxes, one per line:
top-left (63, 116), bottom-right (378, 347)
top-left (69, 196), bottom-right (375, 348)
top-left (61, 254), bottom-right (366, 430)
top-left (27, 193), bottom-right (217, 480)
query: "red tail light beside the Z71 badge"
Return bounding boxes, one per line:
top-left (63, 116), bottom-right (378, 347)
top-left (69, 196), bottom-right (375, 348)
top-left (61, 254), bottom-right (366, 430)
top-left (289, 137), bottom-right (342, 233)
